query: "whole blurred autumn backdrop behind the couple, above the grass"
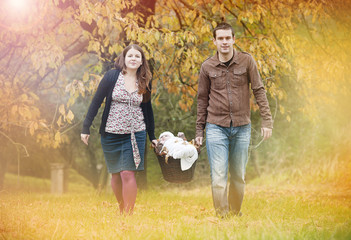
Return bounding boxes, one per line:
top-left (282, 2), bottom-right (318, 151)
top-left (0, 0), bottom-right (351, 191)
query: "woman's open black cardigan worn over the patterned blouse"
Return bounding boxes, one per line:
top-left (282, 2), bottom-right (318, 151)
top-left (82, 69), bottom-right (156, 141)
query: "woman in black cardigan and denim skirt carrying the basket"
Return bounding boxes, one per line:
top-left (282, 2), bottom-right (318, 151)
top-left (81, 44), bottom-right (157, 214)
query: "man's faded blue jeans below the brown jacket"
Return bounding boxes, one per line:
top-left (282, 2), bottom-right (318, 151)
top-left (206, 123), bottom-right (251, 216)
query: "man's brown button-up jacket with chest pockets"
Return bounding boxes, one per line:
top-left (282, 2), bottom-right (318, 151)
top-left (196, 50), bottom-right (273, 137)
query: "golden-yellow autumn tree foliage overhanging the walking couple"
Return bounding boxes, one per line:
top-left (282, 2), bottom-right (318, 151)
top-left (0, 0), bottom-right (351, 188)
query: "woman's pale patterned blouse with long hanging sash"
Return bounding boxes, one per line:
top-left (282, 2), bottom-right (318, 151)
top-left (105, 73), bottom-right (146, 168)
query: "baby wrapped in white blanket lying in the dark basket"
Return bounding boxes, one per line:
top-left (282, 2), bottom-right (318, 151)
top-left (159, 132), bottom-right (198, 171)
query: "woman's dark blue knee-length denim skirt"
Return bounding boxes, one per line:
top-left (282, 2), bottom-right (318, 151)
top-left (101, 131), bottom-right (146, 173)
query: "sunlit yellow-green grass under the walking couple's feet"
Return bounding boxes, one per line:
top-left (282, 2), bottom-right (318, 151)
top-left (0, 175), bottom-right (351, 239)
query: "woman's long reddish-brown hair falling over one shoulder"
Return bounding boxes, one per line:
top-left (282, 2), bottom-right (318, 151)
top-left (115, 44), bottom-right (152, 94)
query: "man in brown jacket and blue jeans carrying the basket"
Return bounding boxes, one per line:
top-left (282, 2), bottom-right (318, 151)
top-left (195, 23), bottom-right (273, 217)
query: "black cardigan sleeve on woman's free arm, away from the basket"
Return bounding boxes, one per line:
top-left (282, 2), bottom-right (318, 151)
top-left (82, 71), bottom-right (112, 134)
